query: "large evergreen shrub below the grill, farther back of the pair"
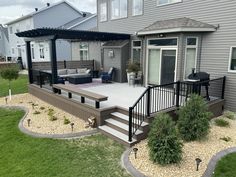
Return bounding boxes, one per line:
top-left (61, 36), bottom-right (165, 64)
top-left (177, 94), bottom-right (211, 141)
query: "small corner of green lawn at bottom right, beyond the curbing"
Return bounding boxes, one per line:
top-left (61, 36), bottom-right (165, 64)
top-left (213, 153), bottom-right (236, 177)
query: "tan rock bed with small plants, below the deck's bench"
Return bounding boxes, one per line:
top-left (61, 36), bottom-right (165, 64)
top-left (0, 94), bottom-right (93, 135)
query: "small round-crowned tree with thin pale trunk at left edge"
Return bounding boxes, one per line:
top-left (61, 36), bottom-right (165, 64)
top-left (0, 66), bottom-right (19, 100)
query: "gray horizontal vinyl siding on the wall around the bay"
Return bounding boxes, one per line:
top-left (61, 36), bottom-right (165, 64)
top-left (97, 0), bottom-right (236, 111)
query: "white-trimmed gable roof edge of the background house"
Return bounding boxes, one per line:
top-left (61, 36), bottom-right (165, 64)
top-left (6, 0), bottom-right (83, 25)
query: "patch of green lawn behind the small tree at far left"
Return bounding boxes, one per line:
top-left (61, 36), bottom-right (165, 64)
top-left (0, 75), bottom-right (28, 97)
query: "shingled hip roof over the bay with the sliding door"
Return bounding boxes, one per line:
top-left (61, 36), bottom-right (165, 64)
top-left (138, 17), bottom-right (216, 35)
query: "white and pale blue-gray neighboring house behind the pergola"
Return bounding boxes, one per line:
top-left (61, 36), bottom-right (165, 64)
top-left (6, 1), bottom-right (97, 67)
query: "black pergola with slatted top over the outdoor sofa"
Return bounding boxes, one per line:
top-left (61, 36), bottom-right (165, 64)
top-left (16, 28), bottom-right (130, 84)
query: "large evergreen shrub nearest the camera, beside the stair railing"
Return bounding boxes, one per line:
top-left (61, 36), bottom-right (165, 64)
top-left (148, 114), bottom-right (183, 165)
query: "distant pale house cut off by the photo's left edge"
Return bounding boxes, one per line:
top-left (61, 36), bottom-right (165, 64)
top-left (0, 24), bottom-right (10, 60)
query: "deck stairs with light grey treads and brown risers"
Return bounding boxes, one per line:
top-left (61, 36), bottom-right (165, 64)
top-left (99, 111), bottom-right (149, 147)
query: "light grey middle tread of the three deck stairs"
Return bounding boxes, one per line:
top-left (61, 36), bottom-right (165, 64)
top-left (105, 118), bottom-right (143, 136)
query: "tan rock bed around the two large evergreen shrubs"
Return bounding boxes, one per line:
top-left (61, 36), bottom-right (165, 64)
top-left (129, 116), bottom-right (236, 177)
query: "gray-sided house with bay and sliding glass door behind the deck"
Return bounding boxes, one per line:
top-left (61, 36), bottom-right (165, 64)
top-left (97, 0), bottom-right (236, 111)
